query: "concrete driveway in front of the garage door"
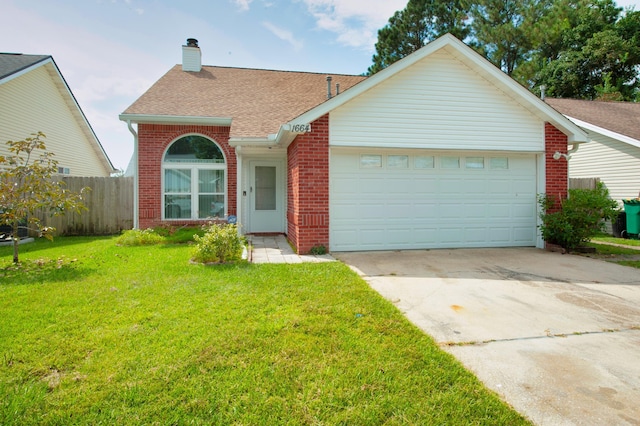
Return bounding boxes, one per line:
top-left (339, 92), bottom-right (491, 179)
top-left (334, 248), bottom-right (640, 425)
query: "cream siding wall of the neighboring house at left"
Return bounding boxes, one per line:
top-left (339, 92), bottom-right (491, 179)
top-left (0, 64), bottom-right (111, 176)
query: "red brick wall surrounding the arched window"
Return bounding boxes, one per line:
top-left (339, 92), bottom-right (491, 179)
top-left (138, 124), bottom-right (236, 229)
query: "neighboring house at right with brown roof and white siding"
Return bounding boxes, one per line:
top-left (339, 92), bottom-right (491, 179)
top-left (545, 98), bottom-right (640, 202)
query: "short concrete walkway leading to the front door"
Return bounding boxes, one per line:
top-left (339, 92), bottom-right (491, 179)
top-left (247, 235), bottom-right (335, 263)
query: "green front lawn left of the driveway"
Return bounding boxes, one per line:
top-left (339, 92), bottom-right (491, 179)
top-left (0, 237), bottom-right (528, 425)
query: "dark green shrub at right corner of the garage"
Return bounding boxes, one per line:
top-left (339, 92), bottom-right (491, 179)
top-left (538, 182), bottom-right (618, 250)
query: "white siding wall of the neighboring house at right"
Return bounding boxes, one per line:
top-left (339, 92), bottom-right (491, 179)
top-left (569, 132), bottom-right (640, 201)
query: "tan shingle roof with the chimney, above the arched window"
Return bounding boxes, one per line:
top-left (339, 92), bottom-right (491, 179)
top-left (122, 65), bottom-right (366, 138)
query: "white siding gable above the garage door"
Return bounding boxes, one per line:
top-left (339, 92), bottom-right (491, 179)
top-left (330, 48), bottom-right (544, 152)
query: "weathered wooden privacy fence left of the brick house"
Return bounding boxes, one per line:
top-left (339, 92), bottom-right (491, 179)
top-left (39, 176), bottom-right (133, 235)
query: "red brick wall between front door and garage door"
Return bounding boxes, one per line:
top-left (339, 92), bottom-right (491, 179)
top-left (287, 115), bottom-right (329, 254)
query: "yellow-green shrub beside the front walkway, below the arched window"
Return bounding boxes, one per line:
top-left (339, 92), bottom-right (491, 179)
top-left (191, 223), bottom-right (244, 263)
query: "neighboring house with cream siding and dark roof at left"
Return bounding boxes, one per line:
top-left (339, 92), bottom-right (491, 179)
top-left (0, 53), bottom-right (115, 176)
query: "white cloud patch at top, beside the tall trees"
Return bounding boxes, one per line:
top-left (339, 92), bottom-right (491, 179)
top-left (303, 0), bottom-right (407, 51)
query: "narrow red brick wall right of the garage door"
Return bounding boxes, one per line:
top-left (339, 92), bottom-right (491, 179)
top-left (544, 123), bottom-right (569, 211)
